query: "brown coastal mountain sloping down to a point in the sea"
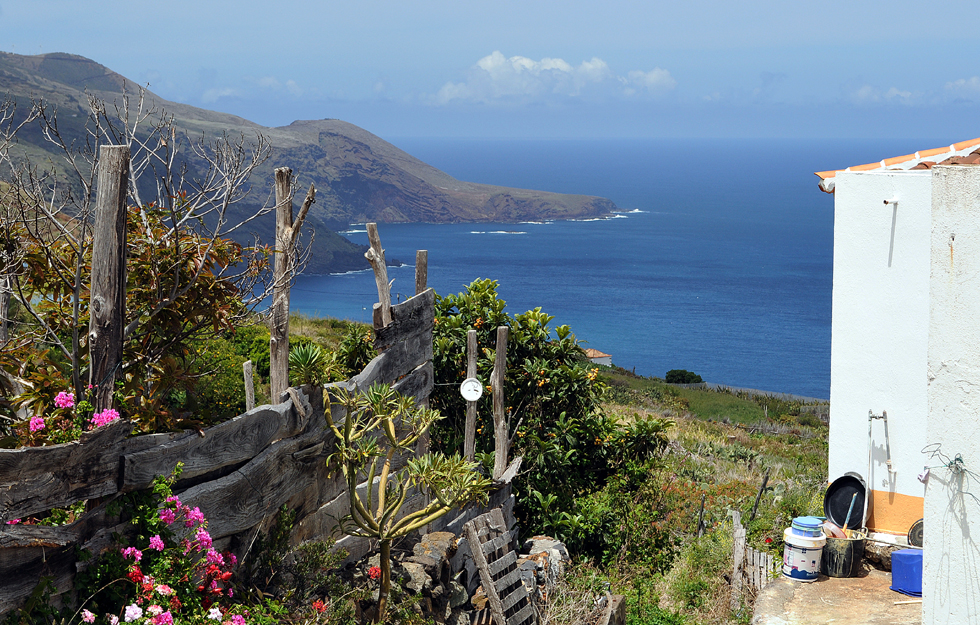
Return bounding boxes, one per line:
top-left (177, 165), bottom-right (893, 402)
top-left (0, 52), bottom-right (616, 273)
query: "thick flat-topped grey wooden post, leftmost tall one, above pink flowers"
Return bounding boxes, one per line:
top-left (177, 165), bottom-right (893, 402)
top-left (88, 145), bottom-right (129, 412)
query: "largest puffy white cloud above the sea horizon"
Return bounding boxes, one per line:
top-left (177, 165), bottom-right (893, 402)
top-left (434, 51), bottom-right (677, 104)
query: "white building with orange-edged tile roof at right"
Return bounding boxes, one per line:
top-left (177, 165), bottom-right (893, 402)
top-left (817, 139), bottom-right (980, 623)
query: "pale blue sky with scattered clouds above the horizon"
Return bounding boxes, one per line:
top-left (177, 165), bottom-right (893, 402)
top-left (0, 0), bottom-right (980, 142)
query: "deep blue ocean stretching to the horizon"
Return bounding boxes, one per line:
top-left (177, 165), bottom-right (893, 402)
top-left (292, 139), bottom-right (943, 398)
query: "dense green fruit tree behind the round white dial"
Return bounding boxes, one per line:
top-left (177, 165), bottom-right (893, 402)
top-left (430, 280), bottom-right (608, 538)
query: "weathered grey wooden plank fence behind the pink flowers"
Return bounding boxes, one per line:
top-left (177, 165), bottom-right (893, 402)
top-left (0, 289), bottom-right (513, 617)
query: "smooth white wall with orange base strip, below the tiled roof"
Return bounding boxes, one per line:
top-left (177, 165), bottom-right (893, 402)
top-left (829, 171), bottom-right (931, 533)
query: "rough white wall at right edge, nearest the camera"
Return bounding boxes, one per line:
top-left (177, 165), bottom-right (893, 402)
top-left (922, 166), bottom-right (980, 625)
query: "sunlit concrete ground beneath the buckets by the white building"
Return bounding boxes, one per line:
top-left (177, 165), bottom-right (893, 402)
top-left (752, 569), bottom-right (922, 625)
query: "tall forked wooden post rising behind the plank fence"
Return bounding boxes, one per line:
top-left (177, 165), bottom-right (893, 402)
top-left (269, 167), bottom-right (316, 404)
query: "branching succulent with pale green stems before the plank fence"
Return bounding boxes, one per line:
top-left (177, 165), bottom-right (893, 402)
top-left (326, 385), bottom-right (491, 622)
